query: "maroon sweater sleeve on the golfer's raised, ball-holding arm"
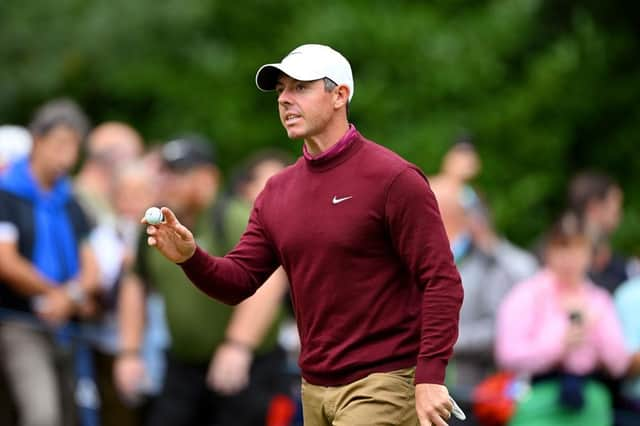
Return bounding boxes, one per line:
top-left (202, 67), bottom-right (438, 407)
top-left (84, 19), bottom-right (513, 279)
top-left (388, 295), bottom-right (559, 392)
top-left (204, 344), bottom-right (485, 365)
top-left (180, 191), bottom-right (279, 305)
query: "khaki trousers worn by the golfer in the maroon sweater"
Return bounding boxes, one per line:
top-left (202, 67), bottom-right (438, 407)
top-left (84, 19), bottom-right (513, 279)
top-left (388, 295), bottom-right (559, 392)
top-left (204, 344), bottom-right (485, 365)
top-left (302, 368), bottom-right (419, 426)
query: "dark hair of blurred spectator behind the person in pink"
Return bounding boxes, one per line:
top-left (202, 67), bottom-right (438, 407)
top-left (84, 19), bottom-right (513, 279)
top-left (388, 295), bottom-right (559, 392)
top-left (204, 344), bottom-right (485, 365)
top-left (568, 171), bottom-right (618, 219)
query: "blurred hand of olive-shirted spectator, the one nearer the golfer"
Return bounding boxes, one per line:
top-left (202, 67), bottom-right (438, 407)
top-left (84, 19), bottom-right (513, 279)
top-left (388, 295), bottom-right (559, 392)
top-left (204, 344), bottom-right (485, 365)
top-left (207, 343), bottom-right (253, 395)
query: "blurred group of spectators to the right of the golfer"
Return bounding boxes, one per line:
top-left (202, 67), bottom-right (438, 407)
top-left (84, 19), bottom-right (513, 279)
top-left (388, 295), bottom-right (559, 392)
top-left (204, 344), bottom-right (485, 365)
top-left (431, 138), bottom-right (640, 426)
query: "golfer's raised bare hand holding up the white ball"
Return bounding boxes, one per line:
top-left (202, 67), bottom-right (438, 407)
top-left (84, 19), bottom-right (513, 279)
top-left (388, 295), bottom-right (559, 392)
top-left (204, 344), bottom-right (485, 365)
top-left (141, 207), bottom-right (196, 263)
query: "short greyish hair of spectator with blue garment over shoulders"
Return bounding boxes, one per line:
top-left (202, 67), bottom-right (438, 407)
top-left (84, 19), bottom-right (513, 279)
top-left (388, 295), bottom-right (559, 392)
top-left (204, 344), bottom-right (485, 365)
top-left (29, 98), bottom-right (89, 139)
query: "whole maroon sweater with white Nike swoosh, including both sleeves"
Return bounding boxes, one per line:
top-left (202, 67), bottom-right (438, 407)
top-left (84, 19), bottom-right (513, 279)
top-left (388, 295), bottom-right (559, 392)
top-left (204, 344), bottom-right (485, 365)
top-left (182, 127), bottom-right (462, 386)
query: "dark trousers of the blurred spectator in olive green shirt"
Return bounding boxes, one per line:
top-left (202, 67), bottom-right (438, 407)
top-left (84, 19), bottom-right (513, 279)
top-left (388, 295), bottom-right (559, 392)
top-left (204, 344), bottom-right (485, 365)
top-left (147, 349), bottom-right (290, 426)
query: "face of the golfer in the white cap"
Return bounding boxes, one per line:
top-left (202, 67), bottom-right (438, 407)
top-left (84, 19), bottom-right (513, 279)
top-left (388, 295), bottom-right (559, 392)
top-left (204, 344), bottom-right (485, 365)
top-left (276, 74), bottom-right (335, 139)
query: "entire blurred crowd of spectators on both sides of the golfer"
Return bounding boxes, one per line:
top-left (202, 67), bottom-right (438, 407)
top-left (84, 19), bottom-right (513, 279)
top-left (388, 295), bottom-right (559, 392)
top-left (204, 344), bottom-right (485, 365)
top-left (0, 99), bottom-right (640, 426)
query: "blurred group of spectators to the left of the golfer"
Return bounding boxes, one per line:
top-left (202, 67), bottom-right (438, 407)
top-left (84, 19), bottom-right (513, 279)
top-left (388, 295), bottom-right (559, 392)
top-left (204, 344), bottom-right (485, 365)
top-left (0, 99), bottom-right (300, 426)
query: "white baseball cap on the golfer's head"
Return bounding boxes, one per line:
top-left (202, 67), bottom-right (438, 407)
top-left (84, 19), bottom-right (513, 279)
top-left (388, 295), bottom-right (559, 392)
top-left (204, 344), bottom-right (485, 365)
top-left (256, 44), bottom-right (354, 102)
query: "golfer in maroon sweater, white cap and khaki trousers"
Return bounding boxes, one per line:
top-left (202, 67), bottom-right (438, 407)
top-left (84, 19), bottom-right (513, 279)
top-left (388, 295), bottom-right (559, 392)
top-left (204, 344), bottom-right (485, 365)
top-left (147, 45), bottom-right (462, 426)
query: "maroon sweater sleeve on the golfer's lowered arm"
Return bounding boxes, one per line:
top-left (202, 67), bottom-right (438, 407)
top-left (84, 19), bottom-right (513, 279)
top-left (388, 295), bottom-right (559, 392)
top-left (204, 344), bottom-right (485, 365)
top-left (385, 168), bottom-right (463, 384)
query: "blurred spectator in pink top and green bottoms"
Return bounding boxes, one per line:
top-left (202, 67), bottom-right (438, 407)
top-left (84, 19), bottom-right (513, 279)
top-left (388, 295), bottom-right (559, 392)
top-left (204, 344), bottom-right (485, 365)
top-left (496, 217), bottom-right (629, 425)
